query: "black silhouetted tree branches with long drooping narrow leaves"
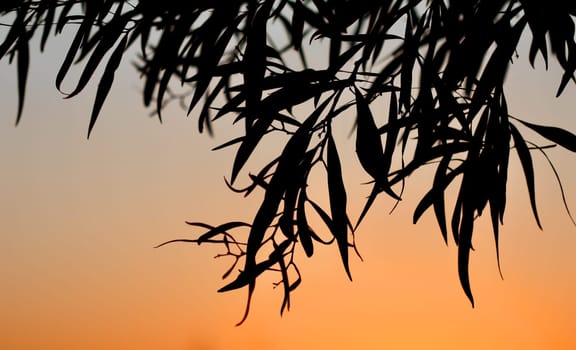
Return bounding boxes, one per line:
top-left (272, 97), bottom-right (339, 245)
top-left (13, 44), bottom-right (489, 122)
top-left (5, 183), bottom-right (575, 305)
top-left (0, 0), bottom-right (576, 320)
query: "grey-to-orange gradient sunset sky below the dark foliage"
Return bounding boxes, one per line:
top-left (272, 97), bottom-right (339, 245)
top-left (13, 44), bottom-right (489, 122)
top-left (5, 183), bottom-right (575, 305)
top-left (0, 23), bottom-right (576, 350)
